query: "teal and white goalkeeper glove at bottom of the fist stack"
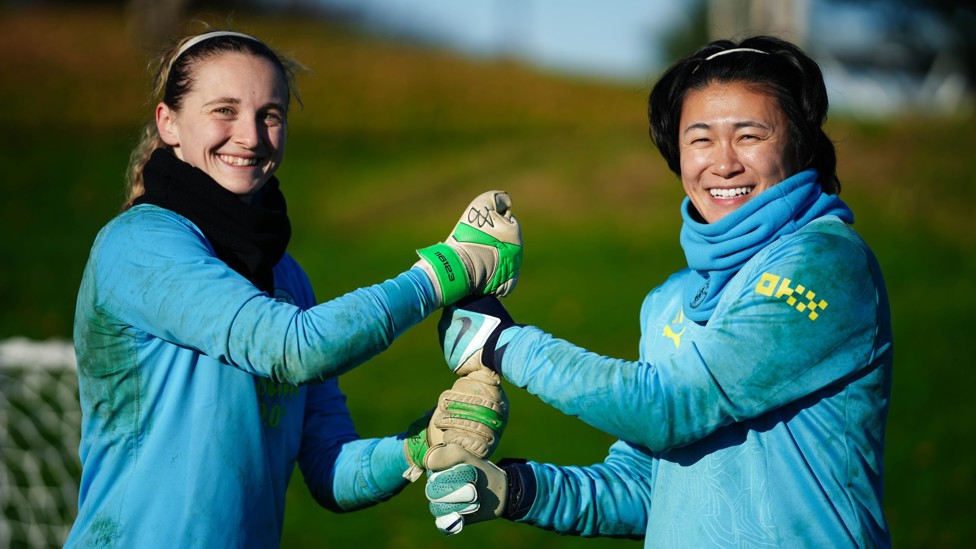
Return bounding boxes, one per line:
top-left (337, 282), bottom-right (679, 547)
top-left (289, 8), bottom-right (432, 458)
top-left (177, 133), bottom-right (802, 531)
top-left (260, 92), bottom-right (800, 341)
top-left (424, 444), bottom-right (536, 536)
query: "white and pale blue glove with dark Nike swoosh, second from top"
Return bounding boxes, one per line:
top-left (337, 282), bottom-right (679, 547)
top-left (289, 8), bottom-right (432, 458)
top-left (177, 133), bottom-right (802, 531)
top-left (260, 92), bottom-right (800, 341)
top-left (437, 296), bottom-right (520, 376)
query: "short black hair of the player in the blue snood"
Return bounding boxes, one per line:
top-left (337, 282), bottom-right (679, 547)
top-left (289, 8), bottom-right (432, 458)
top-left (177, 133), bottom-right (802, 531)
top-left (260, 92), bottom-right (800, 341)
top-left (647, 36), bottom-right (840, 194)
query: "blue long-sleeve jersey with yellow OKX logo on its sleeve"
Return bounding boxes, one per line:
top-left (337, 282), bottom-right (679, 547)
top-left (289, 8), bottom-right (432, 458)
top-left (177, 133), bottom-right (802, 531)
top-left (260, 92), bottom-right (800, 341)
top-left (502, 216), bottom-right (892, 548)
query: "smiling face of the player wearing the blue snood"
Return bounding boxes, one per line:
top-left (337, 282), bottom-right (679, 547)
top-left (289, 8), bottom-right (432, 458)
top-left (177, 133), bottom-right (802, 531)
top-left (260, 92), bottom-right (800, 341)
top-left (678, 82), bottom-right (796, 223)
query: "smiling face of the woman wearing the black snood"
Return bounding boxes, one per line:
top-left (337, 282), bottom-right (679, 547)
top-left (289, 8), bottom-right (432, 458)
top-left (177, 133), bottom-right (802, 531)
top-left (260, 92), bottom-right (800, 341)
top-left (156, 53), bottom-right (288, 202)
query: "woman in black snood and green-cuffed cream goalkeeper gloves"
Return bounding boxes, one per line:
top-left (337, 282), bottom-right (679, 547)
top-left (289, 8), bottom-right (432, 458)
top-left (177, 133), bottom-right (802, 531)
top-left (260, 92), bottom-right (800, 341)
top-left (66, 31), bottom-right (521, 548)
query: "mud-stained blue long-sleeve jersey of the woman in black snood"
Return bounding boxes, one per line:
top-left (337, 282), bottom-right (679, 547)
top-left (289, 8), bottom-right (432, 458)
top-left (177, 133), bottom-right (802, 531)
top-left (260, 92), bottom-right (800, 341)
top-left (67, 205), bottom-right (433, 548)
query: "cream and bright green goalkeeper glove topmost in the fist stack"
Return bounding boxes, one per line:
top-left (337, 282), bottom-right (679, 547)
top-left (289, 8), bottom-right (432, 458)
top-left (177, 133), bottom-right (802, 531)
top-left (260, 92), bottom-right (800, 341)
top-left (416, 191), bottom-right (522, 306)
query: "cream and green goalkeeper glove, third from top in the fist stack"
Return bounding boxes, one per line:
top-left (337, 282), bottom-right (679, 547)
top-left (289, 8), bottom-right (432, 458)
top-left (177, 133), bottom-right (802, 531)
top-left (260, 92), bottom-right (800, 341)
top-left (403, 368), bottom-right (508, 482)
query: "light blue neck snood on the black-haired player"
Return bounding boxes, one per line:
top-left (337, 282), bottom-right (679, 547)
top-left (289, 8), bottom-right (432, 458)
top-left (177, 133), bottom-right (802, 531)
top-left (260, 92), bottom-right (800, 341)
top-left (681, 170), bottom-right (854, 324)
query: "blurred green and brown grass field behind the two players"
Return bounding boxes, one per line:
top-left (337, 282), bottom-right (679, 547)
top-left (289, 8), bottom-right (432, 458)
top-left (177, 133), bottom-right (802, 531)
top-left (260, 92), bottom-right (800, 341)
top-left (0, 8), bottom-right (976, 549)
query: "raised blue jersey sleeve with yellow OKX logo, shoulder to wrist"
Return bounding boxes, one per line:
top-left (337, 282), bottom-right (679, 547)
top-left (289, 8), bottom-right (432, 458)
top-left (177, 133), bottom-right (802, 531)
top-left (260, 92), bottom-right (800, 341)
top-left (502, 223), bottom-right (883, 451)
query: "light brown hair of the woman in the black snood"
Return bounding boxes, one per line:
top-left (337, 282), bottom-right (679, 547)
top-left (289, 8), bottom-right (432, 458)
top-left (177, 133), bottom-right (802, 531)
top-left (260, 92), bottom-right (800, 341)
top-left (122, 30), bottom-right (304, 210)
